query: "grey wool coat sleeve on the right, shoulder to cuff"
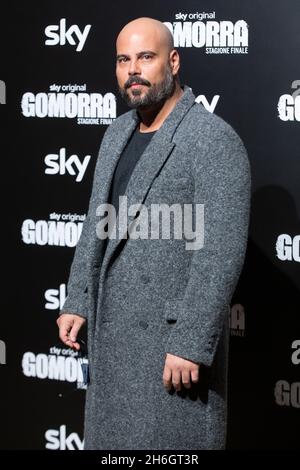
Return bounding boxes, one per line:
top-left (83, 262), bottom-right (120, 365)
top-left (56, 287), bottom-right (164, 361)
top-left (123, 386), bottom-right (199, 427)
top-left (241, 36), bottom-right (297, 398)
top-left (165, 126), bottom-right (251, 366)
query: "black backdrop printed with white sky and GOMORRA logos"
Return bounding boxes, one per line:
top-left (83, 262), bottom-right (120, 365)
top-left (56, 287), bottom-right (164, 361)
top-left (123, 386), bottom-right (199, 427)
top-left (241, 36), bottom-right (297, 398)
top-left (0, 0), bottom-right (300, 450)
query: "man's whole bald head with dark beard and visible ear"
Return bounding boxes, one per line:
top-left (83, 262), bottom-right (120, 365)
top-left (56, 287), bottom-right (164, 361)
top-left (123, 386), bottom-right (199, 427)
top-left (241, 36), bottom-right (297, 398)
top-left (116, 18), bottom-right (180, 109)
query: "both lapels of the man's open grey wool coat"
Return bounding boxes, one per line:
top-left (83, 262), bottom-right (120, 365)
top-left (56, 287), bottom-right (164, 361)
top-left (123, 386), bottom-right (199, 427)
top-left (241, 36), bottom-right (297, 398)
top-left (101, 86), bottom-right (195, 276)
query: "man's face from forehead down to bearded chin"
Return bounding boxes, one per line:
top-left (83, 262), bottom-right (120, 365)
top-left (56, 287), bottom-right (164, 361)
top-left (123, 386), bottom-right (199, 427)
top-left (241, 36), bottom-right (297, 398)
top-left (116, 32), bottom-right (175, 109)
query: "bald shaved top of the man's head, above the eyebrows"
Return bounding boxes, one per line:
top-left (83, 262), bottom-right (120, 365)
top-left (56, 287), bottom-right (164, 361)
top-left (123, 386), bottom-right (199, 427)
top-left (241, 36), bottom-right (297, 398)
top-left (116, 17), bottom-right (174, 54)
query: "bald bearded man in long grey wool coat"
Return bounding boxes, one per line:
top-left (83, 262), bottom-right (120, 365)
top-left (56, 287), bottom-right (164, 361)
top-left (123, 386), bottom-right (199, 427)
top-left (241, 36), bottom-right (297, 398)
top-left (58, 18), bottom-right (250, 450)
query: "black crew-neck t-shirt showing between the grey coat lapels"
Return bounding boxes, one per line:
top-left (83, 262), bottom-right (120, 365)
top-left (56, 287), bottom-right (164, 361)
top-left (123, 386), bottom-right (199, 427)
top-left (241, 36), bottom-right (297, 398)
top-left (108, 127), bottom-right (156, 214)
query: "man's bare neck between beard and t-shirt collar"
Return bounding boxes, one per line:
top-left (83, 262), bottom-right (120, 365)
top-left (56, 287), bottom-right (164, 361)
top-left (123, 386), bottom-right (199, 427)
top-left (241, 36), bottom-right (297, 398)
top-left (138, 82), bottom-right (183, 132)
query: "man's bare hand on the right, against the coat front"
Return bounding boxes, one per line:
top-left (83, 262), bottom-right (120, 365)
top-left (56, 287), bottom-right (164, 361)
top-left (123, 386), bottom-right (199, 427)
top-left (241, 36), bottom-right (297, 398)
top-left (163, 353), bottom-right (200, 391)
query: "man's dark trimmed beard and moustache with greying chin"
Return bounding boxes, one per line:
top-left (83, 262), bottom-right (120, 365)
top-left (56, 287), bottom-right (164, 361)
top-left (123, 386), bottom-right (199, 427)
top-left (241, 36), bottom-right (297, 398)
top-left (119, 66), bottom-right (175, 109)
